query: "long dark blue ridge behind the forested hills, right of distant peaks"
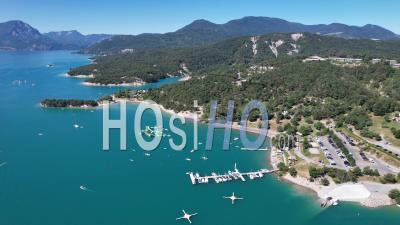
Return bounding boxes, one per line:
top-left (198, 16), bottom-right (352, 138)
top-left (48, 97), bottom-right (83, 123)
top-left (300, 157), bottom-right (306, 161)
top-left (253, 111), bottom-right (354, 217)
top-left (85, 17), bottom-right (399, 54)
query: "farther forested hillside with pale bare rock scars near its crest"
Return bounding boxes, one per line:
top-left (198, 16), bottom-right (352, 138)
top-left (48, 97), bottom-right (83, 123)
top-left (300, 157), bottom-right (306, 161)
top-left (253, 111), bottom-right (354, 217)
top-left (69, 34), bottom-right (400, 84)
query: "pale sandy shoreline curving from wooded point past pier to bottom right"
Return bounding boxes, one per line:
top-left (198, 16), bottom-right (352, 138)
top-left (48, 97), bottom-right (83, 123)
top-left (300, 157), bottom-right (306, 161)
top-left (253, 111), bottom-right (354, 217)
top-left (40, 98), bottom-right (400, 208)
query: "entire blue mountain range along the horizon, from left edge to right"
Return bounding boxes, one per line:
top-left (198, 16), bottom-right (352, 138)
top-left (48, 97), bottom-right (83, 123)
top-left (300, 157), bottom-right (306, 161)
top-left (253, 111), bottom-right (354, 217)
top-left (0, 17), bottom-right (399, 51)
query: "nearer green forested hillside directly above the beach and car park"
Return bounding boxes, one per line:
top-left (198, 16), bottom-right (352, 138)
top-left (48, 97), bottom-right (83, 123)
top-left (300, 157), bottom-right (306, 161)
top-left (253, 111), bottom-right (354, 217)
top-left (144, 62), bottom-right (400, 120)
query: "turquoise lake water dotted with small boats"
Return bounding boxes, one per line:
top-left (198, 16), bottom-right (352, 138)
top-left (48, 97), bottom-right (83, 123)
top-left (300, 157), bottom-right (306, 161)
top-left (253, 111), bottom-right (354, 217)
top-left (0, 51), bottom-right (400, 225)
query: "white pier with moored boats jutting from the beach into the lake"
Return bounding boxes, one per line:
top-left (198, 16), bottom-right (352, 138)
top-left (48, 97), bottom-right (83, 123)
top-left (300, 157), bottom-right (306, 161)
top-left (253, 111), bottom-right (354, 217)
top-left (187, 164), bottom-right (277, 184)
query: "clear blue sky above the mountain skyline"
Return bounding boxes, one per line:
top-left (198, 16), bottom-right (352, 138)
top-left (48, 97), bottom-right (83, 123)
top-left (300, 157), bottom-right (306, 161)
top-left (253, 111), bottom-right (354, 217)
top-left (0, 0), bottom-right (400, 34)
